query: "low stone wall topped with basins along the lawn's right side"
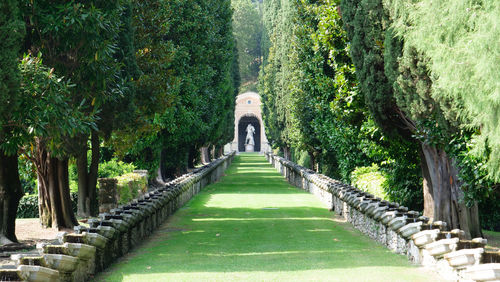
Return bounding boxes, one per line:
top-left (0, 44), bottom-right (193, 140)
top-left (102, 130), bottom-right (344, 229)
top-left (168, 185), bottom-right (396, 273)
top-left (266, 153), bottom-right (500, 281)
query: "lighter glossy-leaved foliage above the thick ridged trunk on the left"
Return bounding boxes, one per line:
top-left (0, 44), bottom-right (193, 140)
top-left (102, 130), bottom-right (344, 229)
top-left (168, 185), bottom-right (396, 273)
top-left (14, 54), bottom-right (95, 152)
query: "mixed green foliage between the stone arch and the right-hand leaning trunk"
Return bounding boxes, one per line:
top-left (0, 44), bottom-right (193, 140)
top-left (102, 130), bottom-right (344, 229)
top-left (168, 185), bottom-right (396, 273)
top-left (259, 0), bottom-right (422, 208)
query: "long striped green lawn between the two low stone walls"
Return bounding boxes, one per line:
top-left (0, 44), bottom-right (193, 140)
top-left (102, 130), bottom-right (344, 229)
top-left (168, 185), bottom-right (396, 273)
top-left (96, 154), bottom-right (439, 281)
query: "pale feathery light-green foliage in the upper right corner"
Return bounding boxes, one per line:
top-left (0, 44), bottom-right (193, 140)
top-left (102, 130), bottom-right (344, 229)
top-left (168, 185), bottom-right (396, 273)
top-left (384, 0), bottom-right (500, 182)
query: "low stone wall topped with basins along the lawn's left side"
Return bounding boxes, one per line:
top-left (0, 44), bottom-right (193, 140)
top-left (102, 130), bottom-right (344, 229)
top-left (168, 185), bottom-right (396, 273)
top-left (0, 152), bottom-right (235, 281)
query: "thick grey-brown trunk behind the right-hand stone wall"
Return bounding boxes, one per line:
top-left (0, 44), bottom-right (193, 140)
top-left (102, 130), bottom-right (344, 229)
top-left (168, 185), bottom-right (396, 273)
top-left (422, 144), bottom-right (482, 238)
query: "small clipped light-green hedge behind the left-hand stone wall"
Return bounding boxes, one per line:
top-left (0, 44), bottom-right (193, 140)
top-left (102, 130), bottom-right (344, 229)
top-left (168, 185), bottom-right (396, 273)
top-left (116, 173), bottom-right (148, 204)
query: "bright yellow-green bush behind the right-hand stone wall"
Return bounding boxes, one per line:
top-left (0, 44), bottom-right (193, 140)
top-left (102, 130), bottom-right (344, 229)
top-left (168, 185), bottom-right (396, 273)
top-left (351, 164), bottom-right (389, 200)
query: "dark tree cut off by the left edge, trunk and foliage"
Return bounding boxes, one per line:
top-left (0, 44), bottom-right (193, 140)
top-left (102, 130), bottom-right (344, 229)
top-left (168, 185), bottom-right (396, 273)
top-left (0, 0), bottom-right (24, 245)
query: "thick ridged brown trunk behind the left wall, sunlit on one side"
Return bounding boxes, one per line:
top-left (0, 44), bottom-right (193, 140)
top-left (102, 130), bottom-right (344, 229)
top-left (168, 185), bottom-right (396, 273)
top-left (35, 141), bottom-right (78, 229)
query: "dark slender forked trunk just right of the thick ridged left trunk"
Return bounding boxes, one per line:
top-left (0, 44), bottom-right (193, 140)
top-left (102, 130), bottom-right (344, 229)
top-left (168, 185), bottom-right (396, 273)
top-left (76, 131), bottom-right (100, 217)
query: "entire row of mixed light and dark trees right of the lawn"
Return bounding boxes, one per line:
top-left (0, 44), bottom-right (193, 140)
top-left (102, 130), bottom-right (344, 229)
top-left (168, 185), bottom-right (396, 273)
top-left (259, 0), bottom-right (499, 237)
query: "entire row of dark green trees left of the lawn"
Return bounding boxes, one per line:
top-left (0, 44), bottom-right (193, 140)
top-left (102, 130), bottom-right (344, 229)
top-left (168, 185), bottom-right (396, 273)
top-left (0, 0), bottom-right (239, 244)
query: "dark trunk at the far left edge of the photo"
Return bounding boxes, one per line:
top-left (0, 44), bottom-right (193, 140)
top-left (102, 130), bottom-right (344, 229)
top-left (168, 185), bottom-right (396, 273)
top-left (0, 150), bottom-right (23, 245)
